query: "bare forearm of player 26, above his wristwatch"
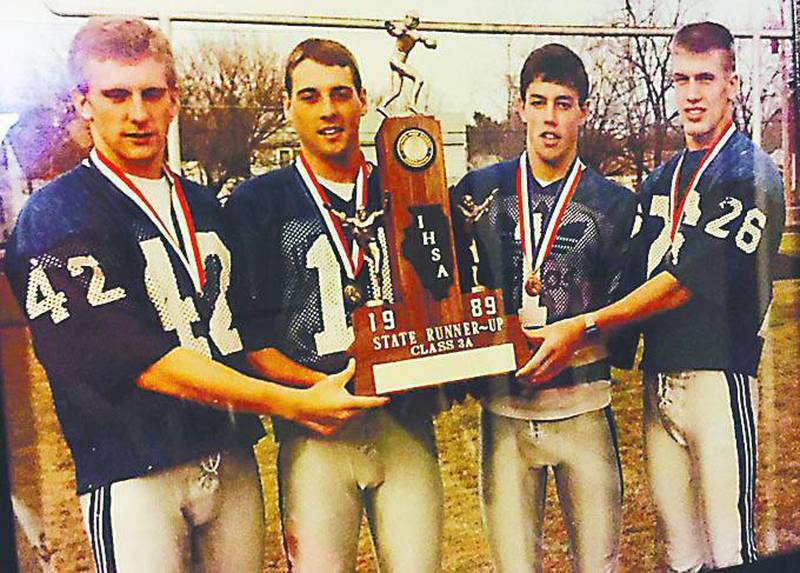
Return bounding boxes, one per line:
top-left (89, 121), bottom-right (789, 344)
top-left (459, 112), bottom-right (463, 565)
top-left (595, 271), bottom-right (692, 334)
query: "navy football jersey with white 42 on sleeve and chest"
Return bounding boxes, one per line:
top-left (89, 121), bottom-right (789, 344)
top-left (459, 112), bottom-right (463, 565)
top-left (6, 164), bottom-right (263, 493)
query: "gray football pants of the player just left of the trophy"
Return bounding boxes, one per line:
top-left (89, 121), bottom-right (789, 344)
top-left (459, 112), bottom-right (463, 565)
top-left (278, 410), bottom-right (443, 573)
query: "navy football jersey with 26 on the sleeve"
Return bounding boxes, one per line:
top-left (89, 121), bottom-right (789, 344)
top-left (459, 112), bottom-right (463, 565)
top-left (636, 132), bottom-right (785, 375)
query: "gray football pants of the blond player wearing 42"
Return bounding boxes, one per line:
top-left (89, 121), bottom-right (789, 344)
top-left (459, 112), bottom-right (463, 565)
top-left (80, 447), bottom-right (264, 573)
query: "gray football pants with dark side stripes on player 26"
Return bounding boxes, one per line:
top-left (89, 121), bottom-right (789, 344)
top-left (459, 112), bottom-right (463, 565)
top-left (644, 370), bottom-right (758, 572)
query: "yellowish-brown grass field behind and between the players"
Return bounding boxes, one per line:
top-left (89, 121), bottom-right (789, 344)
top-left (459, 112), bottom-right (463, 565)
top-left (0, 274), bottom-right (800, 573)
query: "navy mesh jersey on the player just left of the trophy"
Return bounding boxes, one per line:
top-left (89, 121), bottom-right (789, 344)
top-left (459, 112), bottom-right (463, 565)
top-left (225, 165), bottom-right (435, 422)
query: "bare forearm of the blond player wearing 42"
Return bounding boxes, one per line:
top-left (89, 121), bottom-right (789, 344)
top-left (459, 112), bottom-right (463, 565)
top-left (137, 348), bottom-right (301, 419)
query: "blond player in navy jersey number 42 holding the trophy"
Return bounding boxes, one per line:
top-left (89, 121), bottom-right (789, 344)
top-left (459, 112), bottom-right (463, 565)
top-left (6, 19), bottom-right (383, 572)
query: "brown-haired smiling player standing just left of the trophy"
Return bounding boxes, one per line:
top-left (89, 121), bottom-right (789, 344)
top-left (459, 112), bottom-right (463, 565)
top-left (226, 39), bottom-right (442, 573)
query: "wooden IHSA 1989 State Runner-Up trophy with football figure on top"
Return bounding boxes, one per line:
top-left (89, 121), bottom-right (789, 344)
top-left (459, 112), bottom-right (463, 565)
top-left (351, 14), bottom-right (530, 394)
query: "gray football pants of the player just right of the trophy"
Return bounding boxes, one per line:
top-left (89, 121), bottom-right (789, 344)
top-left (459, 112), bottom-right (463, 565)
top-left (481, 407), bottom-right (622, 573)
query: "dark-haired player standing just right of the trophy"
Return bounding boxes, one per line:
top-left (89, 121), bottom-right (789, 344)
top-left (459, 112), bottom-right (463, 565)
top-left (453, 44), bottom-right (636, 572)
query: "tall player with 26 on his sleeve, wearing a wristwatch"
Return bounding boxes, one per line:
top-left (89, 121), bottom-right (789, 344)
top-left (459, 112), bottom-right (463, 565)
top-left (519, 22), bottom-right (784, 571)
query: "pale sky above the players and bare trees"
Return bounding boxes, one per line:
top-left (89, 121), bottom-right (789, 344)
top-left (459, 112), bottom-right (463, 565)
top-left (0, 0), bottom-right (780, 128)
